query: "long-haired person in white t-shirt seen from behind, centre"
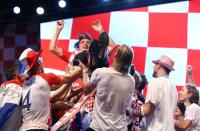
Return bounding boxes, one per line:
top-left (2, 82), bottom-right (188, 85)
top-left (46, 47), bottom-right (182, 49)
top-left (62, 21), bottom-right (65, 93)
top-left (82, 45), bottom-right (135, 131)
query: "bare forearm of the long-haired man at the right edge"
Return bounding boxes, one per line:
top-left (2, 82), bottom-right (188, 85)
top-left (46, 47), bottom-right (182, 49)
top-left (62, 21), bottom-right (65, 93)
top-left (174, 119), bottom-right (192, 130)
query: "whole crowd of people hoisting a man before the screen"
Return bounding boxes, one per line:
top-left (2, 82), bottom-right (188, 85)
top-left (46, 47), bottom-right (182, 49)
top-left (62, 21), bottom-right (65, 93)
top-left (0, 20), bottom-right (200, 131)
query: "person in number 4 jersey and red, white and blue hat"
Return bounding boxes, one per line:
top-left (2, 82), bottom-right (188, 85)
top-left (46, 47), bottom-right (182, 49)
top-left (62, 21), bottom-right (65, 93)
top-left (19, 48), bottom-right (81, 131)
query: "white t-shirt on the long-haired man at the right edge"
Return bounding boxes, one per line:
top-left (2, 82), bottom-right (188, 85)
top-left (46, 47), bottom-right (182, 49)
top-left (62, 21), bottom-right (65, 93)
top-left (184, 103), bottom-right (200, 131)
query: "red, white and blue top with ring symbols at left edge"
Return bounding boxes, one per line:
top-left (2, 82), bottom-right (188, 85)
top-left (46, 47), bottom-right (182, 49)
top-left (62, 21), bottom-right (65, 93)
top-left (0, 80), bottom-right (22, 131)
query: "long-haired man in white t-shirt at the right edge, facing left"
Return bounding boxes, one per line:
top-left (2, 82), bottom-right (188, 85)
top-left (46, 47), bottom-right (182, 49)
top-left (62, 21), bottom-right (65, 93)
top-left (175, 84), bottom-right (200, 131)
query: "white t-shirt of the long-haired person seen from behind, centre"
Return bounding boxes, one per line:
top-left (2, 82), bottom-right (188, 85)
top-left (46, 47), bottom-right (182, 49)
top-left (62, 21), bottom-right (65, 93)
top-left (90, 68), bottom-right (135, 131)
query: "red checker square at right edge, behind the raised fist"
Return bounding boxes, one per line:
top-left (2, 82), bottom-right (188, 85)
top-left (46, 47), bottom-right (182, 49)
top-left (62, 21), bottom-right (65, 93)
top-left (188, 50), bottom-right (200, 86)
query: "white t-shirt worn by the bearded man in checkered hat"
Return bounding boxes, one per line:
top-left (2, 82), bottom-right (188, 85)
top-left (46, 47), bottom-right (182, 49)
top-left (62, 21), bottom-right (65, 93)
top-left (145, 76), bottom-right (178, 131)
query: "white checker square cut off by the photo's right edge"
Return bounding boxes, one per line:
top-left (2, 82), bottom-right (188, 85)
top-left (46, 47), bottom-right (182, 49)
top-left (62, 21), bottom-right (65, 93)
top-left (187, 13), bottom-right (200, 49)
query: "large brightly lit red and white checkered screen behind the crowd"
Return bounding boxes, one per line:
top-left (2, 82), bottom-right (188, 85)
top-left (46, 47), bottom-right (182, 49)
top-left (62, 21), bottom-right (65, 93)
top-left (40, 0), bottom-right (200, 93)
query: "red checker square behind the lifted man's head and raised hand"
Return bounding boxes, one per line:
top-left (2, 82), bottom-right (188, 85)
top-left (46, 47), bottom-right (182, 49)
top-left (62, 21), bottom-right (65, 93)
top-left (71, 13), bottom-right (110, 39)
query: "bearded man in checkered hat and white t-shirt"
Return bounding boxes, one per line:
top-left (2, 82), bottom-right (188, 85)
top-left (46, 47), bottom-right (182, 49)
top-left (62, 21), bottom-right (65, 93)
top-left (132, 55), bottom-right (178, 131)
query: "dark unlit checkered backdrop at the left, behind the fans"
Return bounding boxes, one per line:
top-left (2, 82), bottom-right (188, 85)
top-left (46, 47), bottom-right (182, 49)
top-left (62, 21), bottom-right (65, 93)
top-left (0, 22), bottom-right (40, 83)
